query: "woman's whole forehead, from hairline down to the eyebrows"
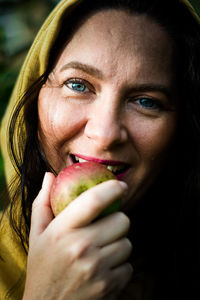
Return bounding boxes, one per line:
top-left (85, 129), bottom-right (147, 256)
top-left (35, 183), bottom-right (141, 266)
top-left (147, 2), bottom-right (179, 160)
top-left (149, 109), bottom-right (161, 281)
top-left (54, 9), bottom-right (173, 83)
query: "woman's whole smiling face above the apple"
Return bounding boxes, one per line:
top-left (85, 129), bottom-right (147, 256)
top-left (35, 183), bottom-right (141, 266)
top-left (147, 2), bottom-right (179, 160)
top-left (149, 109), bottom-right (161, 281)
top-left (38, 9), bottom-right (177, 211)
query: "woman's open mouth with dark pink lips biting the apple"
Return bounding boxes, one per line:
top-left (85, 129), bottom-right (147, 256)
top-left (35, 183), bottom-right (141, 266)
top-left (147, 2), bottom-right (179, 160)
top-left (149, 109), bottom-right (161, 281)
top-left (70, 154), bottom-right (130, 180)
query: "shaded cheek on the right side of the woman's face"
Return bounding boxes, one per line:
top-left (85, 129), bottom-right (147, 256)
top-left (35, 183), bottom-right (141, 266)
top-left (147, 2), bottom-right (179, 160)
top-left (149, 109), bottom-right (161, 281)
top-left (124, 115), bottom-right (176, 205)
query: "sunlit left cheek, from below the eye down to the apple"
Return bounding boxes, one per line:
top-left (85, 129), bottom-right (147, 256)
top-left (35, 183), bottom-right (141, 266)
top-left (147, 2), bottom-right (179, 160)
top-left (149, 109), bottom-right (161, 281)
top-left (38, 89), bottom-right (89, 172)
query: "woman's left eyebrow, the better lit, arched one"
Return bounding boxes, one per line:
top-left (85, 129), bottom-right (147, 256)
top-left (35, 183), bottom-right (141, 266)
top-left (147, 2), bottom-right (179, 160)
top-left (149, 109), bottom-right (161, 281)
top-left (60, 61), bottom-right (103, 79)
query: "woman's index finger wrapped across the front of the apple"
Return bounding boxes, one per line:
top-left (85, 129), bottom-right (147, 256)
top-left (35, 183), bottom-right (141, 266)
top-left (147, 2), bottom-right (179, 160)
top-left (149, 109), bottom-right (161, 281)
top-left (51, 180), bottom-right (127, 228)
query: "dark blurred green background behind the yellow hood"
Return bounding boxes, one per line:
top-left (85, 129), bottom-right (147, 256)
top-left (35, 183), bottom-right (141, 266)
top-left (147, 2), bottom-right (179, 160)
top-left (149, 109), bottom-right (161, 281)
top-left (0, 0), bottom-right (200, 208)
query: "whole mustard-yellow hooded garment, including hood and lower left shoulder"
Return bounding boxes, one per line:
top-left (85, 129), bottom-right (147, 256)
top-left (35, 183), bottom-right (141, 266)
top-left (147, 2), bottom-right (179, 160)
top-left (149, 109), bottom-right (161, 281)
top-left (0, 0), bottom-right (200, 300)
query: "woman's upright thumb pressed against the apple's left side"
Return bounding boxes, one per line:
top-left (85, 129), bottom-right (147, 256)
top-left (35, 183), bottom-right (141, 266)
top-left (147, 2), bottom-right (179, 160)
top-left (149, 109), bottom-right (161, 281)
top-left (30, 173), bottom-right (55, 243)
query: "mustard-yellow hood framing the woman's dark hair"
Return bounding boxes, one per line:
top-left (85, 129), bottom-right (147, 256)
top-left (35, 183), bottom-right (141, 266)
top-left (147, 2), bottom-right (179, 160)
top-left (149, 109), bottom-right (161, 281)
top-left (1, 0), bottom-right (200, 184)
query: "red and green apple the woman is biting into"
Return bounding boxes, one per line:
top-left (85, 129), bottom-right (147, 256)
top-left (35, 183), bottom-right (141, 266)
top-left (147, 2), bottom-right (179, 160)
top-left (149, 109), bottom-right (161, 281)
top-left (50, 162), bottom-right (121, 217)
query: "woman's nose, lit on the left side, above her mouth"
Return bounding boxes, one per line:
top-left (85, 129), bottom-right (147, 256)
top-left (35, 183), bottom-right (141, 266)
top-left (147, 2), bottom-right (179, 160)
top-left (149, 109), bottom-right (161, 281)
top-left (85, 96), bottom-right (128, 150)
